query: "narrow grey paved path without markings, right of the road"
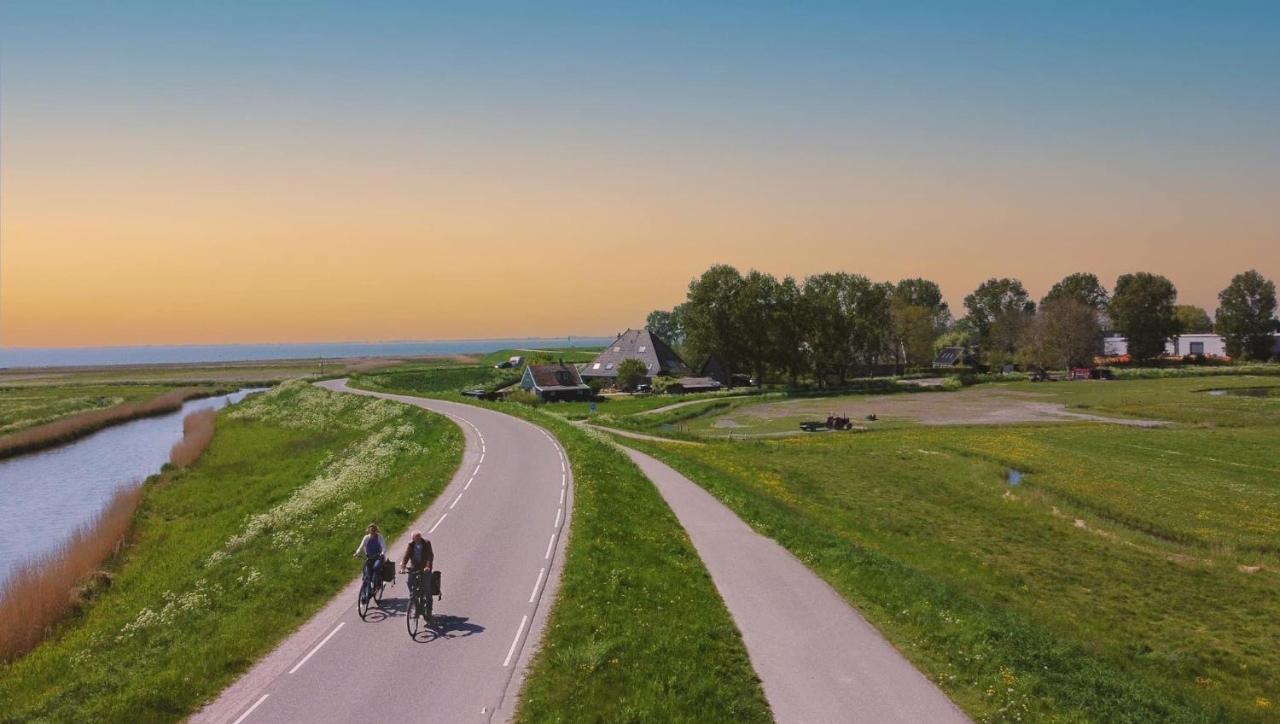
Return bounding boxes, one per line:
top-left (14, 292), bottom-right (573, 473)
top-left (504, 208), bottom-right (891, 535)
top-left (625, 448), bottom-right (968, 724)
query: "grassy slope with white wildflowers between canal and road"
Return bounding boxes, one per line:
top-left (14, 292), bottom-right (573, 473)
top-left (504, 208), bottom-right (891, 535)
top-left (0, 382), bottom-right (462, 721)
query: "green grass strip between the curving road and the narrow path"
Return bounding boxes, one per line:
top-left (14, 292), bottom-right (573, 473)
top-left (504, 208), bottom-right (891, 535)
top-left (353, 375), bottom-right (772, 723)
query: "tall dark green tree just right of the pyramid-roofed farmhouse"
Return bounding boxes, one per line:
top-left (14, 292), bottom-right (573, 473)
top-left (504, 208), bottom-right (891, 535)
top-left (681, 264), bottom-right (750, 374)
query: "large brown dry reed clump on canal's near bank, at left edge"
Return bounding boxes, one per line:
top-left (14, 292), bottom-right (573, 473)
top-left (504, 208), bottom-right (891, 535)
top-left (0, 486), bottom-right (142, 660)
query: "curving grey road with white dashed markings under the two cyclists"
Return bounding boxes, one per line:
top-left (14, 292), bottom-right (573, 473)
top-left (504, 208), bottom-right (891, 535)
top-left (192, 380), bottom-right (573, 724)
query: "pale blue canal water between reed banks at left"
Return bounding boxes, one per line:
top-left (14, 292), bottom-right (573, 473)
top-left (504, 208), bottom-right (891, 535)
top-left (0, 390), bottom-right (253, 583)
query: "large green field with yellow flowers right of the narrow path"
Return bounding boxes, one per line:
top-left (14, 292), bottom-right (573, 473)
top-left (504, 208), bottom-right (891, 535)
top-left (614, 377), bottom-right (1280, 721)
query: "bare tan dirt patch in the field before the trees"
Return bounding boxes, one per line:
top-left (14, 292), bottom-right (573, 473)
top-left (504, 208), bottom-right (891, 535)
top-left (721, 386), bottom-right (1164, 427)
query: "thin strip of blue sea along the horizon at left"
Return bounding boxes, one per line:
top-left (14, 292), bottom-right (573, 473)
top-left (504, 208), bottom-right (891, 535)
top-left (0, 336), bottom-right (613, 368)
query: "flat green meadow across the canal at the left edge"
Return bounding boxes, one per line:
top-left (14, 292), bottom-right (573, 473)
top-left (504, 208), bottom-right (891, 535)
top-left (0, 384), bottom-right (206, 435)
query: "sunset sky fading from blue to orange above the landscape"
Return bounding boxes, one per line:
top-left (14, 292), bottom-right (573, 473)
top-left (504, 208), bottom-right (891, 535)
top-left (0, 0), bottom-right (1280, 347)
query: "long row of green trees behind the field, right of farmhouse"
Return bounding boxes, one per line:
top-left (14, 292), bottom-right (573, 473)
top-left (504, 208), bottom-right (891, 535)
top-left (648, 265), bottom-right (1280, 384)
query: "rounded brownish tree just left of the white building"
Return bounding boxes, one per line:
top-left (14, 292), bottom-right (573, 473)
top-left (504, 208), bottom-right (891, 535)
top-left (1019, 295), bottom-right (1102, 370)
